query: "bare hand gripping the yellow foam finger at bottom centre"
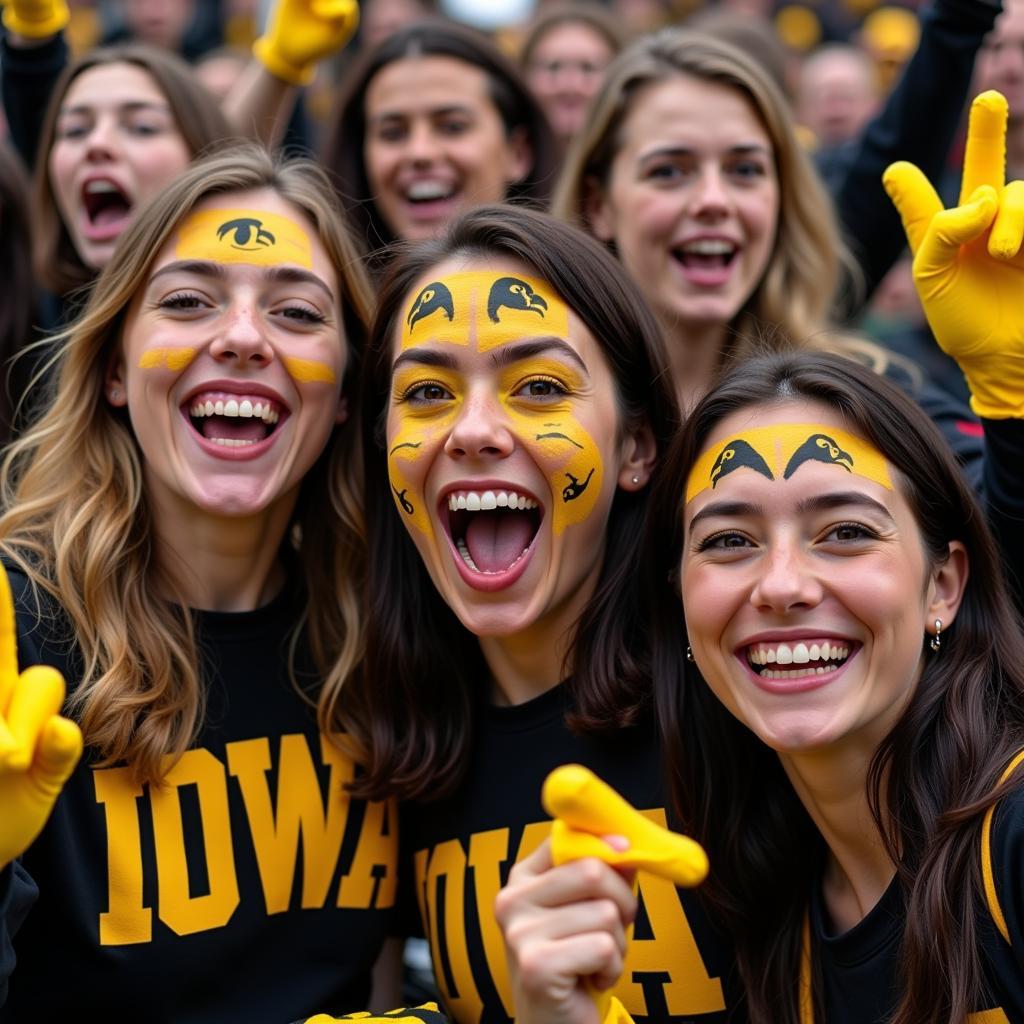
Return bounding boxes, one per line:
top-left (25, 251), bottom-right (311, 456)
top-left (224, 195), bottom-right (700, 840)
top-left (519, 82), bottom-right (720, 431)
top-left (495, 841), bottom-right (636, 1024)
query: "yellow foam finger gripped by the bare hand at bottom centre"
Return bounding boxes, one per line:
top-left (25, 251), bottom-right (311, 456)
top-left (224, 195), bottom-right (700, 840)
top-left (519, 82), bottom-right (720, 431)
top-left (541, 765), bottom-right (708, 1024)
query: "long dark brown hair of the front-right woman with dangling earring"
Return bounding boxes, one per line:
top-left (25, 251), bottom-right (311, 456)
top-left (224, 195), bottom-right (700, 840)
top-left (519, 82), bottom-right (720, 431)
top-left (646, 352), bottom-right (1024, 1024)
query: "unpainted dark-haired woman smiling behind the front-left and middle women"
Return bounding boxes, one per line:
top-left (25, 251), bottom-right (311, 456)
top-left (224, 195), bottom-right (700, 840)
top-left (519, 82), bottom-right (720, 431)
top-left (322, 22), bottom-right (557, 260)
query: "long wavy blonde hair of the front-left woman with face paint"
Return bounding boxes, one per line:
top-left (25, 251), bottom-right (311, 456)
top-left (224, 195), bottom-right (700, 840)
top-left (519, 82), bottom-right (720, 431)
top-left (0, 145), bottom-right (371, 781)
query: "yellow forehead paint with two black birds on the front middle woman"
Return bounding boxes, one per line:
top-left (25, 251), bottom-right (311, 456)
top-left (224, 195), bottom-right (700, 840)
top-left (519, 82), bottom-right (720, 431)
top-left (401, 270), bottom-right (569, 352)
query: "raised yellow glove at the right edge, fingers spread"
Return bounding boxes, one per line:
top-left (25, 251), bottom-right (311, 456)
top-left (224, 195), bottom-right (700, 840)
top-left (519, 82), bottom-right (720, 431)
top-left (882, 91), bottom-right (1024, 420)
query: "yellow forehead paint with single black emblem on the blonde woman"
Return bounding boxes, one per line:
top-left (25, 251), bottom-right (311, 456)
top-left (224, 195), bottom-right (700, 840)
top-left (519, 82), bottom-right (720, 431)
top-left (174, 210), bottom-right (313, 270)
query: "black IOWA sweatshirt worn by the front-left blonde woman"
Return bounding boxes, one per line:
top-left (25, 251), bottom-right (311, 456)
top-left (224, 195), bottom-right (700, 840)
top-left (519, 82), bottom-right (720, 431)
top-left (0, 572), bottom-right (397, 1024)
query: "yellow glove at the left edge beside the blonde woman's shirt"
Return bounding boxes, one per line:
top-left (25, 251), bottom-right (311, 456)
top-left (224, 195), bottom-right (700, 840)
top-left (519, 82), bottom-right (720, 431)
top-left (0, 568), bottom-right (82, 867)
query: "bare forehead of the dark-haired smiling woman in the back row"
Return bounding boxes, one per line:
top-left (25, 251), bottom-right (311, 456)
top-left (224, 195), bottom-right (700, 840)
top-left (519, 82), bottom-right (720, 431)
top-left (366, 55), bottom-right (490, 118)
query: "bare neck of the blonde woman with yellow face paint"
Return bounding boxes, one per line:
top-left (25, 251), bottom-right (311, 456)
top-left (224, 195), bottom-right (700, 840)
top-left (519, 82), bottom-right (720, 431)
top-left (154, 485), bottom-right (297, 611)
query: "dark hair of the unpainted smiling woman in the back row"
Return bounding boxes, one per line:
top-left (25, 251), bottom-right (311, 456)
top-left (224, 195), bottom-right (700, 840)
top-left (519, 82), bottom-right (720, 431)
top-left (321, 20), bottom-right (558, 251)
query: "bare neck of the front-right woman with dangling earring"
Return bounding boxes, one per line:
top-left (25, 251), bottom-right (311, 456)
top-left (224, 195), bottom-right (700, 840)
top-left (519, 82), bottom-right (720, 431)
top-left (779, 743), bottom-right (896, 933)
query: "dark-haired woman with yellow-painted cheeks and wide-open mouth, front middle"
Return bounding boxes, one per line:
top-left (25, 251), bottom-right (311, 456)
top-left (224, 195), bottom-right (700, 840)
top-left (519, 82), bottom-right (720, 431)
top-left (345, 207), bottom-right (731, 1024)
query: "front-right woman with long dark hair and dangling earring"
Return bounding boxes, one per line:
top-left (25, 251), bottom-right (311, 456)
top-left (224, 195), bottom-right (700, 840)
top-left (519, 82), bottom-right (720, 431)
top-left (503, 353), bottom-right (1024, 1024)
